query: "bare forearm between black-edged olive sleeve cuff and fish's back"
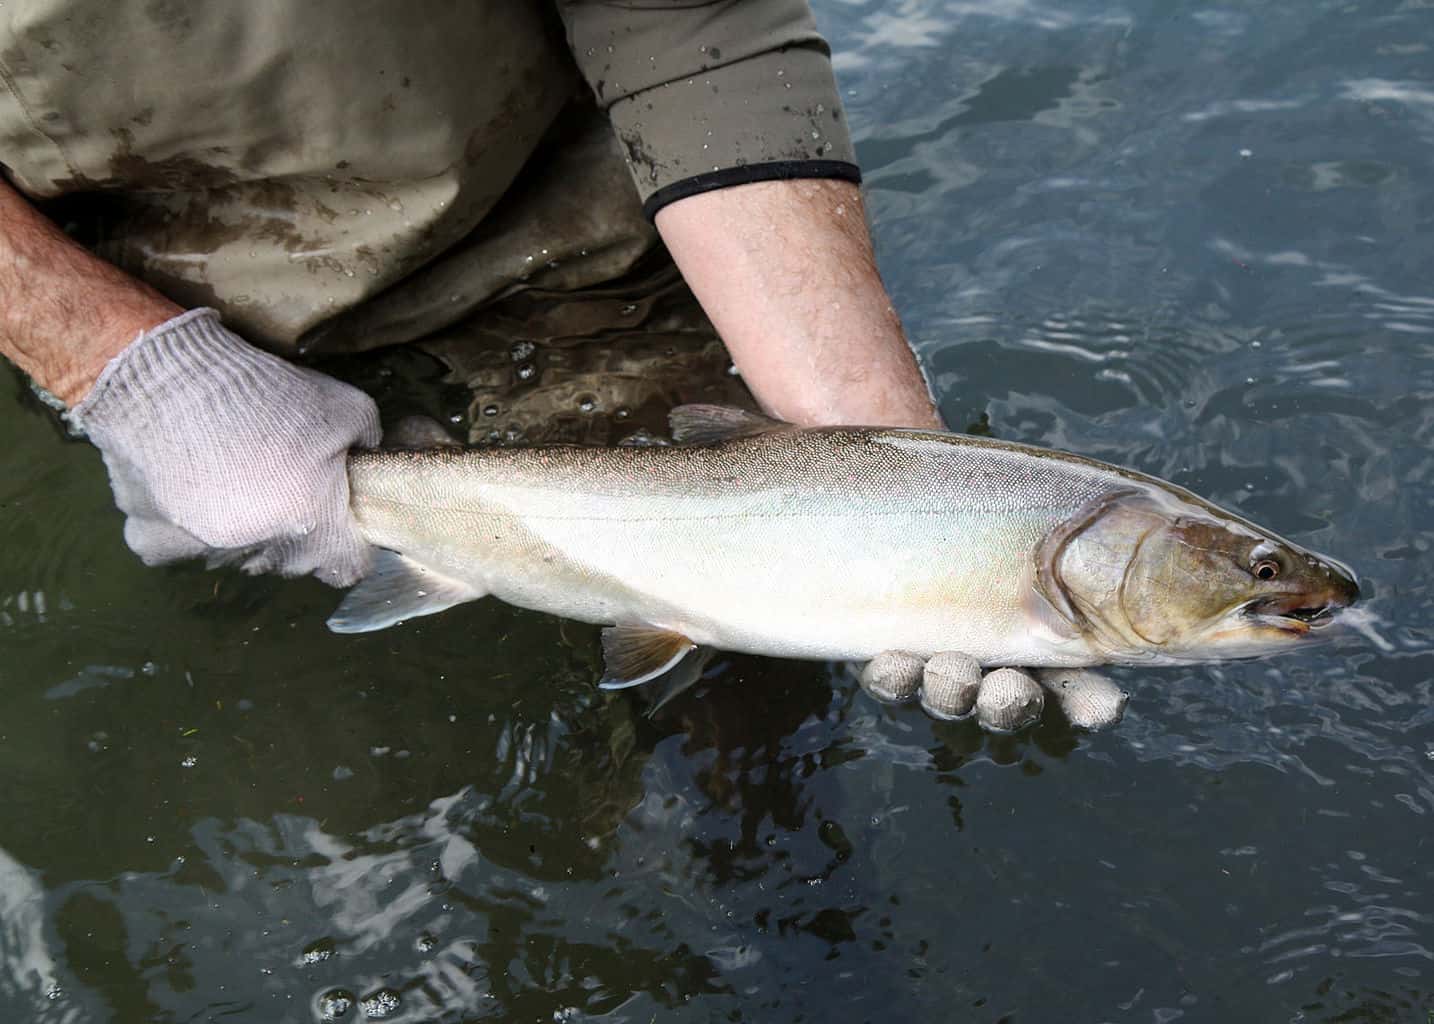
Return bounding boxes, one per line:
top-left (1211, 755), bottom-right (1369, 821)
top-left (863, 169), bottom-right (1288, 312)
top-left (657, 179), bottom-right (941, 429)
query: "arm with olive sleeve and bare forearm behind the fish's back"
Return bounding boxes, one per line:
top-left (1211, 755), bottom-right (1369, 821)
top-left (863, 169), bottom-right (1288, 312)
top-left (558, 0), bottom-right (939, 427)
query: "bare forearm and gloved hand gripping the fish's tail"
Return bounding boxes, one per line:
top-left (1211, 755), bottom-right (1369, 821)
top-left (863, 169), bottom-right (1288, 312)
top-left (0, 176), bottom-right (379, 585)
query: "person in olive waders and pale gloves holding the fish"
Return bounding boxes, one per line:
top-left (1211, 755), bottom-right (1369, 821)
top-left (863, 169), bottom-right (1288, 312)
top-left (0, 0), bottom-right (939, 587)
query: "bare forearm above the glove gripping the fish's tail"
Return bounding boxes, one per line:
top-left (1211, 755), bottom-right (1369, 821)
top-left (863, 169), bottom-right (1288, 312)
top-left (0, 181), bottom-right (181, 407)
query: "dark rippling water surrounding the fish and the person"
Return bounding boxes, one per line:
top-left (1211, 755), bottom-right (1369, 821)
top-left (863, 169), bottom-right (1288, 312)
top-left (0, 0), bottom-right (1434, 1023)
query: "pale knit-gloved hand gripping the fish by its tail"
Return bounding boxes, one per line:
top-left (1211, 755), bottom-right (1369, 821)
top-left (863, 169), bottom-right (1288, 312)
top-left (69, 310), bottom-right (380, 587)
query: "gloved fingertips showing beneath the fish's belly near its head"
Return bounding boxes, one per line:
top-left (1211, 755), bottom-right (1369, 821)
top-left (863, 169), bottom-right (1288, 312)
top-left (860, 651), bottom-right (1130, 733)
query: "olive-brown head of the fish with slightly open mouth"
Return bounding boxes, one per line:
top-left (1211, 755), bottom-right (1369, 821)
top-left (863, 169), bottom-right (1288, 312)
top-left (1038, 488), bottom-right (1359, 663)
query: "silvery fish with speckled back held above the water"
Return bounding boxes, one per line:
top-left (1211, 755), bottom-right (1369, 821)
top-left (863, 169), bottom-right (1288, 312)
top-left (328, 406), bottom-right (1359, 687)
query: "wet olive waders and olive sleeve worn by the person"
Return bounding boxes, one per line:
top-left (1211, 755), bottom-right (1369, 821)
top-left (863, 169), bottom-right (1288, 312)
top-left (0, 0), bottom-right (856, 440)
